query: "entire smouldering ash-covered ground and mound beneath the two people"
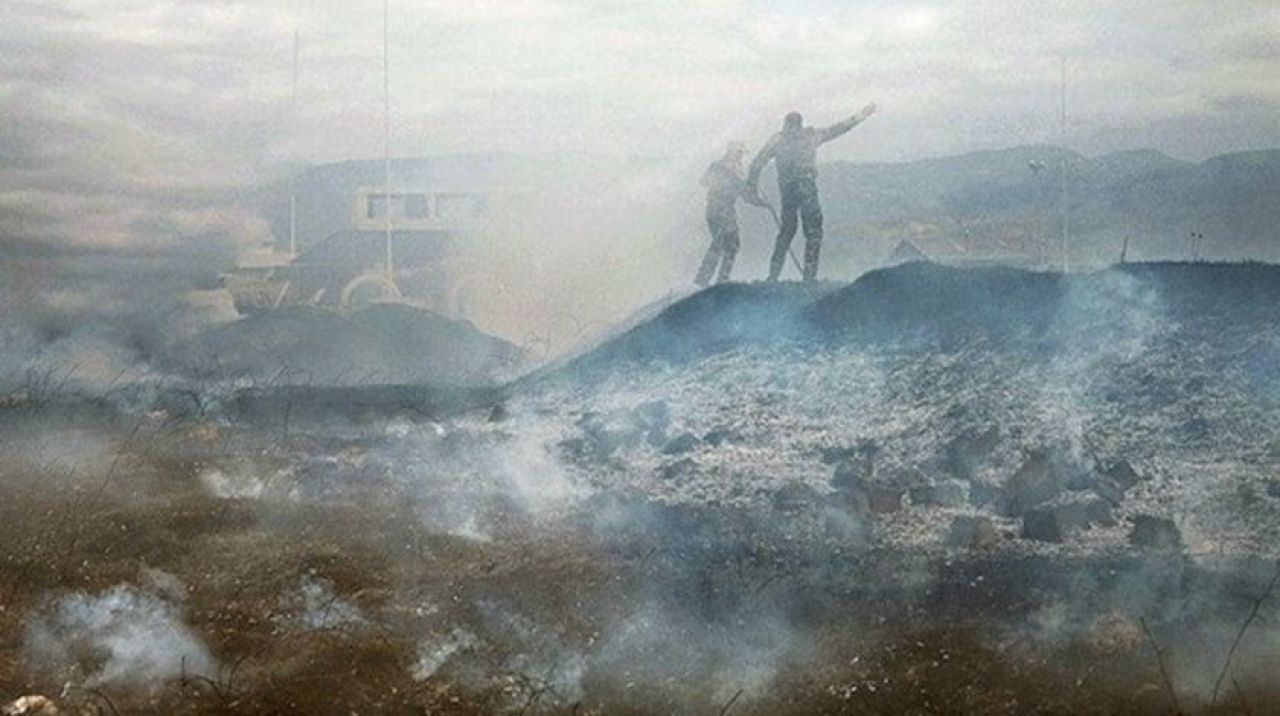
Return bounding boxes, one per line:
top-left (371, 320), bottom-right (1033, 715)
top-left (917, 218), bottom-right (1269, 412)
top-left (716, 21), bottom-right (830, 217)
top-left (0, 263), bottom-right (1280, 713)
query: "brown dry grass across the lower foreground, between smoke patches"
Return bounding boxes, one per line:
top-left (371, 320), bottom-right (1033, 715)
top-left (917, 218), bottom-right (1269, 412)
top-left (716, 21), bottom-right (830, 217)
top-left (0, 412), bottom-right (1280, 715)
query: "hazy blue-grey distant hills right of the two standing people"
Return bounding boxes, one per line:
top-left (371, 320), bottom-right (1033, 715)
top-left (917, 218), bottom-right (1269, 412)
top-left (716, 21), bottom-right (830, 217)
top-left (822, 146), bottom-right (1280, 270)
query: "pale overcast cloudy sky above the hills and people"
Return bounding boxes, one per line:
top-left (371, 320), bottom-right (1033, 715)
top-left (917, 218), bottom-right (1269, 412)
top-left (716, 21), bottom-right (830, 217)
top-left (0, 0), bottom-right (1280, 246)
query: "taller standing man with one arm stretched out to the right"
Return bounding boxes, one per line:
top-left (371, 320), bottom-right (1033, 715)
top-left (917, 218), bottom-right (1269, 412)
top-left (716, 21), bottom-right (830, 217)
top-left (746, 104), bottom-right (876, 281)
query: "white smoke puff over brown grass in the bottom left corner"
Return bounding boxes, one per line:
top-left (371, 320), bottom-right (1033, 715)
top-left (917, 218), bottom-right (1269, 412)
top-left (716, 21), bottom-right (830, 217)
top-left (23, 585), bottom-right (214, 688)
